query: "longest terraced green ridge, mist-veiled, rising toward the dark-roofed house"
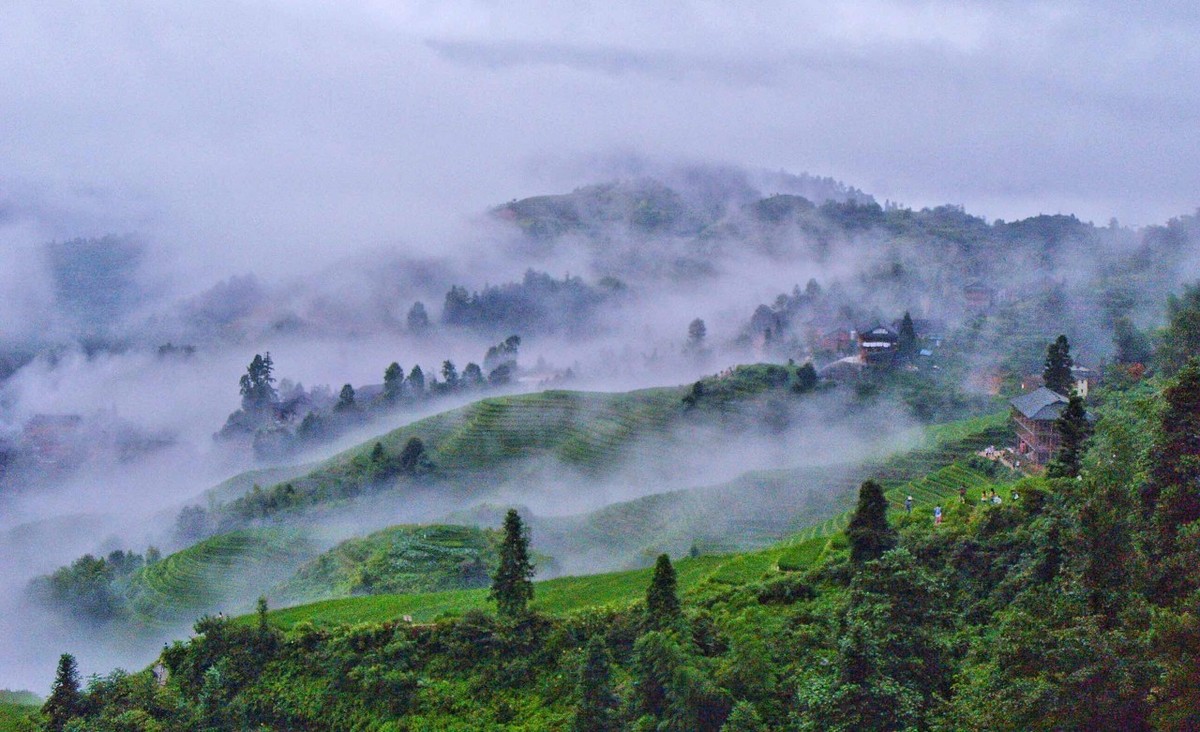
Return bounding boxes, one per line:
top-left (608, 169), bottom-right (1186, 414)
top-left (215, 364), bottom-right (830, 523)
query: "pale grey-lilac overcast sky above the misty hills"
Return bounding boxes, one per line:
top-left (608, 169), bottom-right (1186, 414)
top-left (0, 0), bottom-right (1200, 270)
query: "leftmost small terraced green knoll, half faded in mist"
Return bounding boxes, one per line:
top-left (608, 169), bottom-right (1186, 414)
top-left (125, 529), bottom-right (317, 626)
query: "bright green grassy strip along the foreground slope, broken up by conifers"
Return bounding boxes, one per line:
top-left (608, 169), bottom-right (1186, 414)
top-left (262, 415), bottom-right (1003, 628)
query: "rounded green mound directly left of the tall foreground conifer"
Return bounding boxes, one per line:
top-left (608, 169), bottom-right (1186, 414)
top-left (269, 524), bottom-right (497, 605)
